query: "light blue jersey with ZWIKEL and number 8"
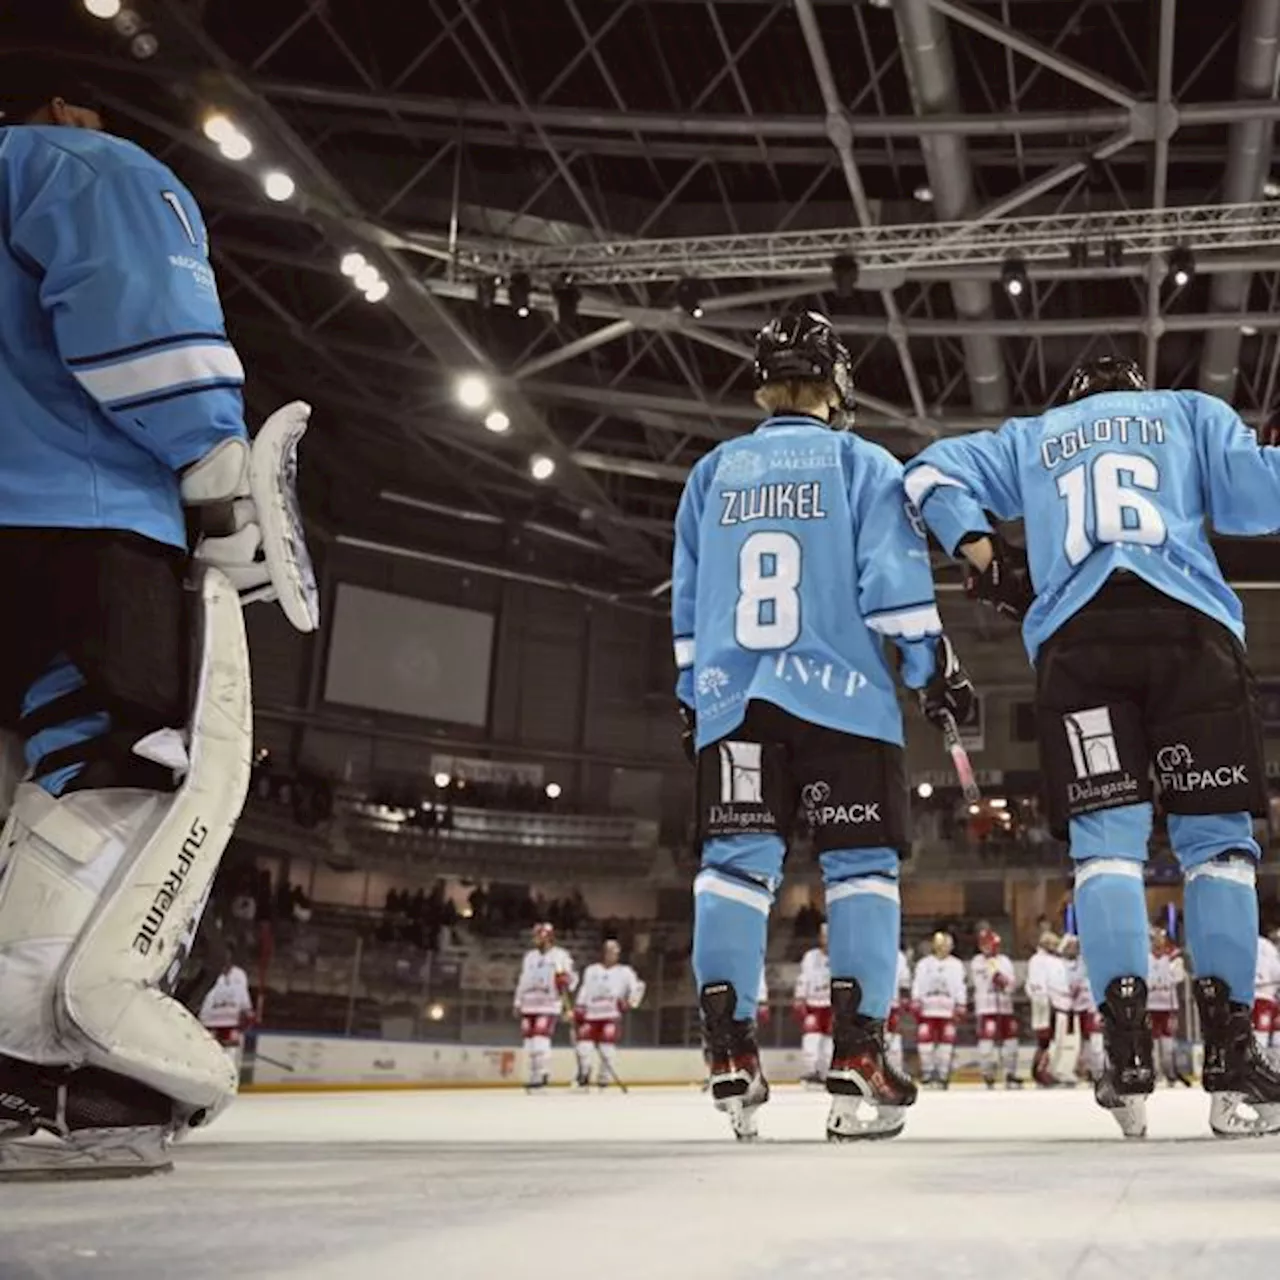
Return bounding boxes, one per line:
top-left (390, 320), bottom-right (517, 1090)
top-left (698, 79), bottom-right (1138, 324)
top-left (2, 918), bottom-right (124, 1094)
top-left (671, 416), bottom-right (942, 748)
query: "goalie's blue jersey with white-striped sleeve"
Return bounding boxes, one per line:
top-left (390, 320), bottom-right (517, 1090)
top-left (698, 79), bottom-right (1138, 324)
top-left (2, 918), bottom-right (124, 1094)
top-left (0, 125), bottom-right (244, 547)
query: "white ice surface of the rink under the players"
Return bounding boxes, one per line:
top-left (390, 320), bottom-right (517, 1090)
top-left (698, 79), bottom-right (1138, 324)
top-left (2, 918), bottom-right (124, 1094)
top-left (0, 1088), bottom-right (1280, 1280)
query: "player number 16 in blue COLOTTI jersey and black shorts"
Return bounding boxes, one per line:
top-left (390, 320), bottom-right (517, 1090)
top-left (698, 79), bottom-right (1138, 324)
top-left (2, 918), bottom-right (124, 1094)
top-left (906, 357), bottom-right (1280, 1137)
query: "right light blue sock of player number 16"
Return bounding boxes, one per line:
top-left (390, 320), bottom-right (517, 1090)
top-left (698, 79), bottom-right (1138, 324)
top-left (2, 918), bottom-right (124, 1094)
top-left (1185, 855), bottom-right (1258, 1005)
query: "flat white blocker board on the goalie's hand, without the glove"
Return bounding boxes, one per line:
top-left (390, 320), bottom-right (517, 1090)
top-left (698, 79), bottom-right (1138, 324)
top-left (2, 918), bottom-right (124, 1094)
top-left (244, 401), bottom-right (320, 631)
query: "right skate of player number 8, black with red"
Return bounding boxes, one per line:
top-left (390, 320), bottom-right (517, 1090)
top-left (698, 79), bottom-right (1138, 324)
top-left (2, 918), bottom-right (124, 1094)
top-left (827, 978), bottom-right (916, 1142)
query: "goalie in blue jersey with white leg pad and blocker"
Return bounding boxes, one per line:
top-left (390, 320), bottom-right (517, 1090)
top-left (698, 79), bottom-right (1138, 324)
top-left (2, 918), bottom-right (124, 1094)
top-left (0, 60), bottom-right (317, 1179)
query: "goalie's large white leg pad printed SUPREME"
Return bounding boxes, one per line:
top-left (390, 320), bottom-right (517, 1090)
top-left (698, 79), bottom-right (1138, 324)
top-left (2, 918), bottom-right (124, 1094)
top-left (0, 570), bottom-right (252, 1115)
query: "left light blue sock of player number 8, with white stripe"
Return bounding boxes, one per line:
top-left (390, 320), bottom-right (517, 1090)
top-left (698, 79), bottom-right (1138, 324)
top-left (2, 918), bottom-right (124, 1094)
top-left (694, 836), bottom-right (783, 1020)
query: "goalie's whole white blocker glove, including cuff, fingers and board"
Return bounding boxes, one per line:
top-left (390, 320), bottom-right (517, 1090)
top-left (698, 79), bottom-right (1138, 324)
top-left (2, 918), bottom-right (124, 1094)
top-left (180, 401), bottom-right (320, 631)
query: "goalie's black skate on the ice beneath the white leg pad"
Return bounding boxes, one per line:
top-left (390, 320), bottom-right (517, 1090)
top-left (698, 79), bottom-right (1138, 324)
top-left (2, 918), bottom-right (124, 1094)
top-left (0, 1057), bottom-right (180, 1181)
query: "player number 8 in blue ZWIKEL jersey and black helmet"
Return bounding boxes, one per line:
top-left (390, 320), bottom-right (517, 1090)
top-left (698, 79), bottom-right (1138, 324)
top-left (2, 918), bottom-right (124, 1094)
top-left (672, 312), bottom-right (973, 1140)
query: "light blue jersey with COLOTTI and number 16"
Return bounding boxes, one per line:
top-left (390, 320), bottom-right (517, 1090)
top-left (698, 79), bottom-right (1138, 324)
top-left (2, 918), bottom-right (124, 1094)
top-left (906, 390), bottom-right (1280, 660)
